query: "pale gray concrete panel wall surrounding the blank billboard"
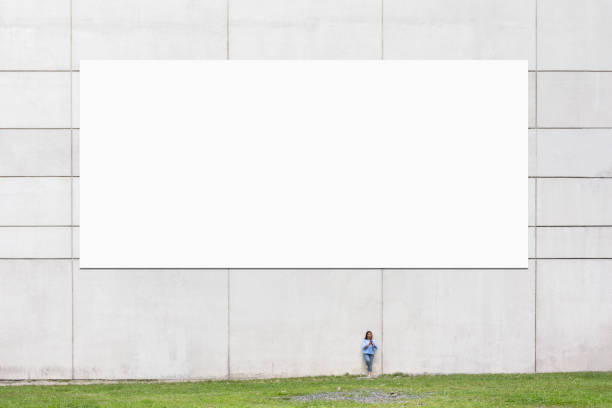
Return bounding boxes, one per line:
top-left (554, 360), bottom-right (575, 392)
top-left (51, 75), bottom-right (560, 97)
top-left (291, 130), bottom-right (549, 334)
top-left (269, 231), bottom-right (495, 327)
top-left (0, 0), bottom-right (612, 379)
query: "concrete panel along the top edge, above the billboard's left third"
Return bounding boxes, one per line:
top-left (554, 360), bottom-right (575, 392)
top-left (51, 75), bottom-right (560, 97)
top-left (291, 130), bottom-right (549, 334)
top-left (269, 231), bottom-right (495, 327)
top-left (72, 0), bottom-right (227, 69)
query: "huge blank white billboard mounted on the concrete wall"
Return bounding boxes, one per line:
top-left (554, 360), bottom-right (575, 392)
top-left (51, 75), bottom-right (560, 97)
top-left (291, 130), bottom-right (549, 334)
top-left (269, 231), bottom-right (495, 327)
top-left (80, 61), bottom-right (527, 268)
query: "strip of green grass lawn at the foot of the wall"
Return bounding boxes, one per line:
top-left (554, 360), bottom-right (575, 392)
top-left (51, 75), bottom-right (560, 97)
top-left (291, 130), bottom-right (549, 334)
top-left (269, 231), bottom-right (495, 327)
top-left (0, 373), bottom-right (612, 408)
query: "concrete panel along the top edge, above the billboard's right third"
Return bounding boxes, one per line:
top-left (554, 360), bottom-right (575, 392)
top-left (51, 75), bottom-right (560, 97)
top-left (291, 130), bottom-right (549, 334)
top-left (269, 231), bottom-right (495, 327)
top-left (384, 0), bottom-right (536, 69)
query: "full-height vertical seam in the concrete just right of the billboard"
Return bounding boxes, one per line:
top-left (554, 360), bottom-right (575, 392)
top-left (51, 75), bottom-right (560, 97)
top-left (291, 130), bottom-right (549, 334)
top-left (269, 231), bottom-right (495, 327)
top-left (533, 0), bottom-right (540, 373)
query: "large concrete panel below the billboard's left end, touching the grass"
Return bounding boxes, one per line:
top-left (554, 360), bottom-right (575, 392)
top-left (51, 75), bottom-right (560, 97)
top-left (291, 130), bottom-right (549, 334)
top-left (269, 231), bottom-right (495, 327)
top-left (74, 268), bottom-right (227, 379)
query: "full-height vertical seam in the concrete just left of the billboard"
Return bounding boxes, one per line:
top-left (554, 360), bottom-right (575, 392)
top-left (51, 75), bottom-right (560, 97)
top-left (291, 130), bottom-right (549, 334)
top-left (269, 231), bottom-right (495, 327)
top-left (69, 0), bottom-right (74, 379)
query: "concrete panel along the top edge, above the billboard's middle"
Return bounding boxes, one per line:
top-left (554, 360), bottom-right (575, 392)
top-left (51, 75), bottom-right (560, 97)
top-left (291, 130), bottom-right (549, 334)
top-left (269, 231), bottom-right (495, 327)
top-left (229, 0), bottom-right (382, 59)
